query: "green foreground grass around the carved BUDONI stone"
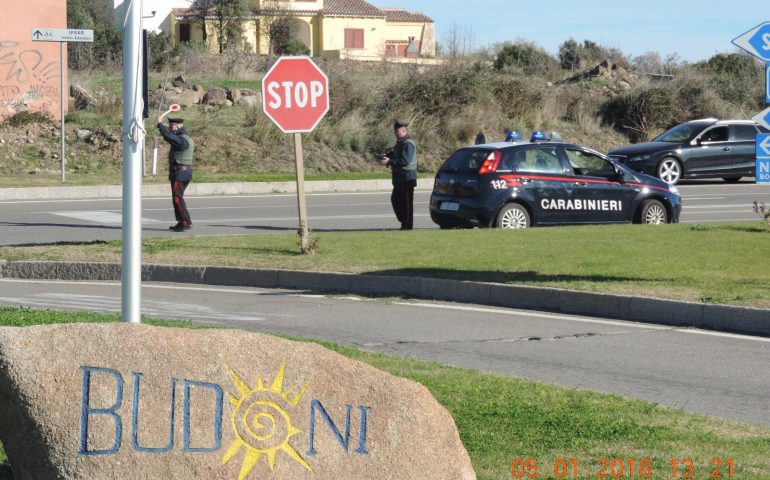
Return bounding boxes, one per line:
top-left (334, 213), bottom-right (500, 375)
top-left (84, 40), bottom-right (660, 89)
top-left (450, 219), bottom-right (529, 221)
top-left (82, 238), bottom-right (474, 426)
top-left (0, 307), bottom-right (770, 480)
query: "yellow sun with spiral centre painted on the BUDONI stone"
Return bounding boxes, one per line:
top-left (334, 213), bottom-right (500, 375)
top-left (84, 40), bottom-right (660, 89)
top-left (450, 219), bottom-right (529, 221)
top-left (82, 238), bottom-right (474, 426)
top-left (222, 362), bottom-right (313, 480)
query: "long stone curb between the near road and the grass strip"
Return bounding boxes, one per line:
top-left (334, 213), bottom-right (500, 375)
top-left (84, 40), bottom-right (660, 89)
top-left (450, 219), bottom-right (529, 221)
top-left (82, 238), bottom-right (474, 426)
top-left (0, 260), bottom-right (770, 337)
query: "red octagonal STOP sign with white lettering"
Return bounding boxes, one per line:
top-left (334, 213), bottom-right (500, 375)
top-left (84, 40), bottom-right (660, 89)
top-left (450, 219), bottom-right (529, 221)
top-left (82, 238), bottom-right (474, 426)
top-left (262, 56), bottom-right (329, 133)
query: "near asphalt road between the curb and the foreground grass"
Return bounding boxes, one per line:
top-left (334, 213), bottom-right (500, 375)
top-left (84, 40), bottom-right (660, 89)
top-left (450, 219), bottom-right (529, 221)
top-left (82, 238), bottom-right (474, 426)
top-left (0, 279), bottom-right (770, 426)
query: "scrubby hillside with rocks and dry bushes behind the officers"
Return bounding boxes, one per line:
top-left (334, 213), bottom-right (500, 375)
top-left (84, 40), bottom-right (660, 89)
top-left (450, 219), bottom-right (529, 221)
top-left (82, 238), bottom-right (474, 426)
top-left (0, 45), bottom-right (763, 187)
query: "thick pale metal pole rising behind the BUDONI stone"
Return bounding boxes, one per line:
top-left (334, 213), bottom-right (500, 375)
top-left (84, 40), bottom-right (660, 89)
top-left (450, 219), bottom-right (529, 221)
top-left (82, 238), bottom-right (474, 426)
top-left (121, 0), bottom-right (144, 323)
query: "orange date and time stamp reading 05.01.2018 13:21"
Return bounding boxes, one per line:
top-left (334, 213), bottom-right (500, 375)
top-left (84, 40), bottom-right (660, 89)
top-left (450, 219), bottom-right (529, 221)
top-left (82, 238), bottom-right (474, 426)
top-left (511, 457), bottom-right (734, 480)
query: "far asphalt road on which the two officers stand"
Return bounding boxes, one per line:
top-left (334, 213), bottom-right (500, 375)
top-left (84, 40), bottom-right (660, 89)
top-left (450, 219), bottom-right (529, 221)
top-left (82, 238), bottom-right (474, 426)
top-left (0, 180), bottom-right (770, 245)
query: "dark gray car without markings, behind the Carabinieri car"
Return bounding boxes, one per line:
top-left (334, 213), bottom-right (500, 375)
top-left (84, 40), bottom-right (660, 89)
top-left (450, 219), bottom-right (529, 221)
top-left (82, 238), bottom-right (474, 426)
top-left (608, 118), bottom-right (767, 185)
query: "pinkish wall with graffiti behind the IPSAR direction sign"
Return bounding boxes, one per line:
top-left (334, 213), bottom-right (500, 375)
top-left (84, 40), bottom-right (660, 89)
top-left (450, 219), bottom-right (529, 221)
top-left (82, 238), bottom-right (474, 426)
top-left (0, 0), bottom-right (69, 121)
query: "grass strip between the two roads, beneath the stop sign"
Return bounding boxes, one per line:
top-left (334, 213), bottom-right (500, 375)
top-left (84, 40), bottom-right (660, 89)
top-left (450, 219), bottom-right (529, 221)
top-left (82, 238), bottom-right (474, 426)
top-left (0, 219), bottom-right (770, 308)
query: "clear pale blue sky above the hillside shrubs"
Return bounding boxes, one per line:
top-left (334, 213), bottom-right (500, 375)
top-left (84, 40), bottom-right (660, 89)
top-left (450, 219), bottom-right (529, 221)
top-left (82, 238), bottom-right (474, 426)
top-left (368, 0), bottom-right (770, 62)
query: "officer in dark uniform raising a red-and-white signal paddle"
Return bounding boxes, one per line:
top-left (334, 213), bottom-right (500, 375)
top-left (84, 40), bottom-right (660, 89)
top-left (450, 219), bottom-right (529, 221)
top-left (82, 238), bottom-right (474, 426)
top-left (158, 116), bottom-right (195, 232)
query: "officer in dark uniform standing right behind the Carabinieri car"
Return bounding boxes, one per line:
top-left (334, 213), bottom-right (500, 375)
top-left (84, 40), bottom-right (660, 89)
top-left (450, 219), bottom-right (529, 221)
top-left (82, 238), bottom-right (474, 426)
top-left (380, 120), bottom-right (417, 230)
